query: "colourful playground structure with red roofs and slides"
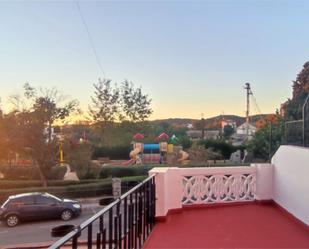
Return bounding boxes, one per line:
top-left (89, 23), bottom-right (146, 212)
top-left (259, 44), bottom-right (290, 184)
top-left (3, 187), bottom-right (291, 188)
top-left (125, 133), bottom-right (189, 165)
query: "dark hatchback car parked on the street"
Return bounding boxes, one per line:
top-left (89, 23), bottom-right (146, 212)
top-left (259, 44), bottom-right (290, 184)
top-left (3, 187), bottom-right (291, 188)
top-left (0, 193), bottom-right (81, 227)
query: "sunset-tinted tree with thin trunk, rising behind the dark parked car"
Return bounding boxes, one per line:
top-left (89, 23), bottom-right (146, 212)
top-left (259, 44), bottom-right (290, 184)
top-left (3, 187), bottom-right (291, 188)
top-left (5, 84), bottom-right (78, 186)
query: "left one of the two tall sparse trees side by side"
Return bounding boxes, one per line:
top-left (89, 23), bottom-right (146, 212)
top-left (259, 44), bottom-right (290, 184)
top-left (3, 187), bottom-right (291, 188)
top-left (89, 79), bottom-right (121, 125)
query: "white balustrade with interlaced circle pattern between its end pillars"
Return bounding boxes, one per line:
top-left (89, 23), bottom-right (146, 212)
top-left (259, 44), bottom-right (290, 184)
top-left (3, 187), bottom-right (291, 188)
top-left (149, 164), bottom-right (273, 217)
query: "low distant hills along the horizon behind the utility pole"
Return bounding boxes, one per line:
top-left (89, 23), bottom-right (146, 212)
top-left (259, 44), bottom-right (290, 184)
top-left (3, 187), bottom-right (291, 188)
top-left (150, 114), bottom-right (269, 129)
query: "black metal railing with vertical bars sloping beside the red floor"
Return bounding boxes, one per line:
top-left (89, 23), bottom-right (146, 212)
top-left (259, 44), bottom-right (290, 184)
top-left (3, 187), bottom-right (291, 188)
top-left (49, 175), bottom-right (156, 249)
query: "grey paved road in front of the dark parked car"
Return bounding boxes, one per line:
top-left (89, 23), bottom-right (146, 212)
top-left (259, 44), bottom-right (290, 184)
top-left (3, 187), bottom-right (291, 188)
top-left (0, 206), bottom-right (102, 249)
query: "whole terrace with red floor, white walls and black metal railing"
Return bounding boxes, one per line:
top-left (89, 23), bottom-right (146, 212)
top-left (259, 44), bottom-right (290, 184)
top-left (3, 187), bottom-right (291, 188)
top-left (50, 146), bottom-right (309, 249)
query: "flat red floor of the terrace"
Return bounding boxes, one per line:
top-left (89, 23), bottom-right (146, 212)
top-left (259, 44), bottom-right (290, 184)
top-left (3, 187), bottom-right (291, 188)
top-left (143, 203), bottom-right (309, 249)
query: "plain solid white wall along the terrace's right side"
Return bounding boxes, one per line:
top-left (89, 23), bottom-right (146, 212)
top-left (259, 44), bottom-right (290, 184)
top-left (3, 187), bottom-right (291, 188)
top-left (272, 145), bottom-right (309, 225)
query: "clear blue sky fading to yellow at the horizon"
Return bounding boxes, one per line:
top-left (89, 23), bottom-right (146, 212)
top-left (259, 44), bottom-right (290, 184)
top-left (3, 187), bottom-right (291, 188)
top-left (0, 0), bottom-right (309, 119)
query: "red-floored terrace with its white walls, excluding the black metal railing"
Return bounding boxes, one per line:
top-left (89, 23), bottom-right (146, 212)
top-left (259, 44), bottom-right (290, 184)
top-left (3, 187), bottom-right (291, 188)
top-left (144, 146), bottom-right (309, 249)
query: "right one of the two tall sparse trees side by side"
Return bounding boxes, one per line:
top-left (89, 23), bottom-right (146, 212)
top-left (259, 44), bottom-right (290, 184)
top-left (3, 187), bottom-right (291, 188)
top-left (121, 80), bottom-right (152, 122)
